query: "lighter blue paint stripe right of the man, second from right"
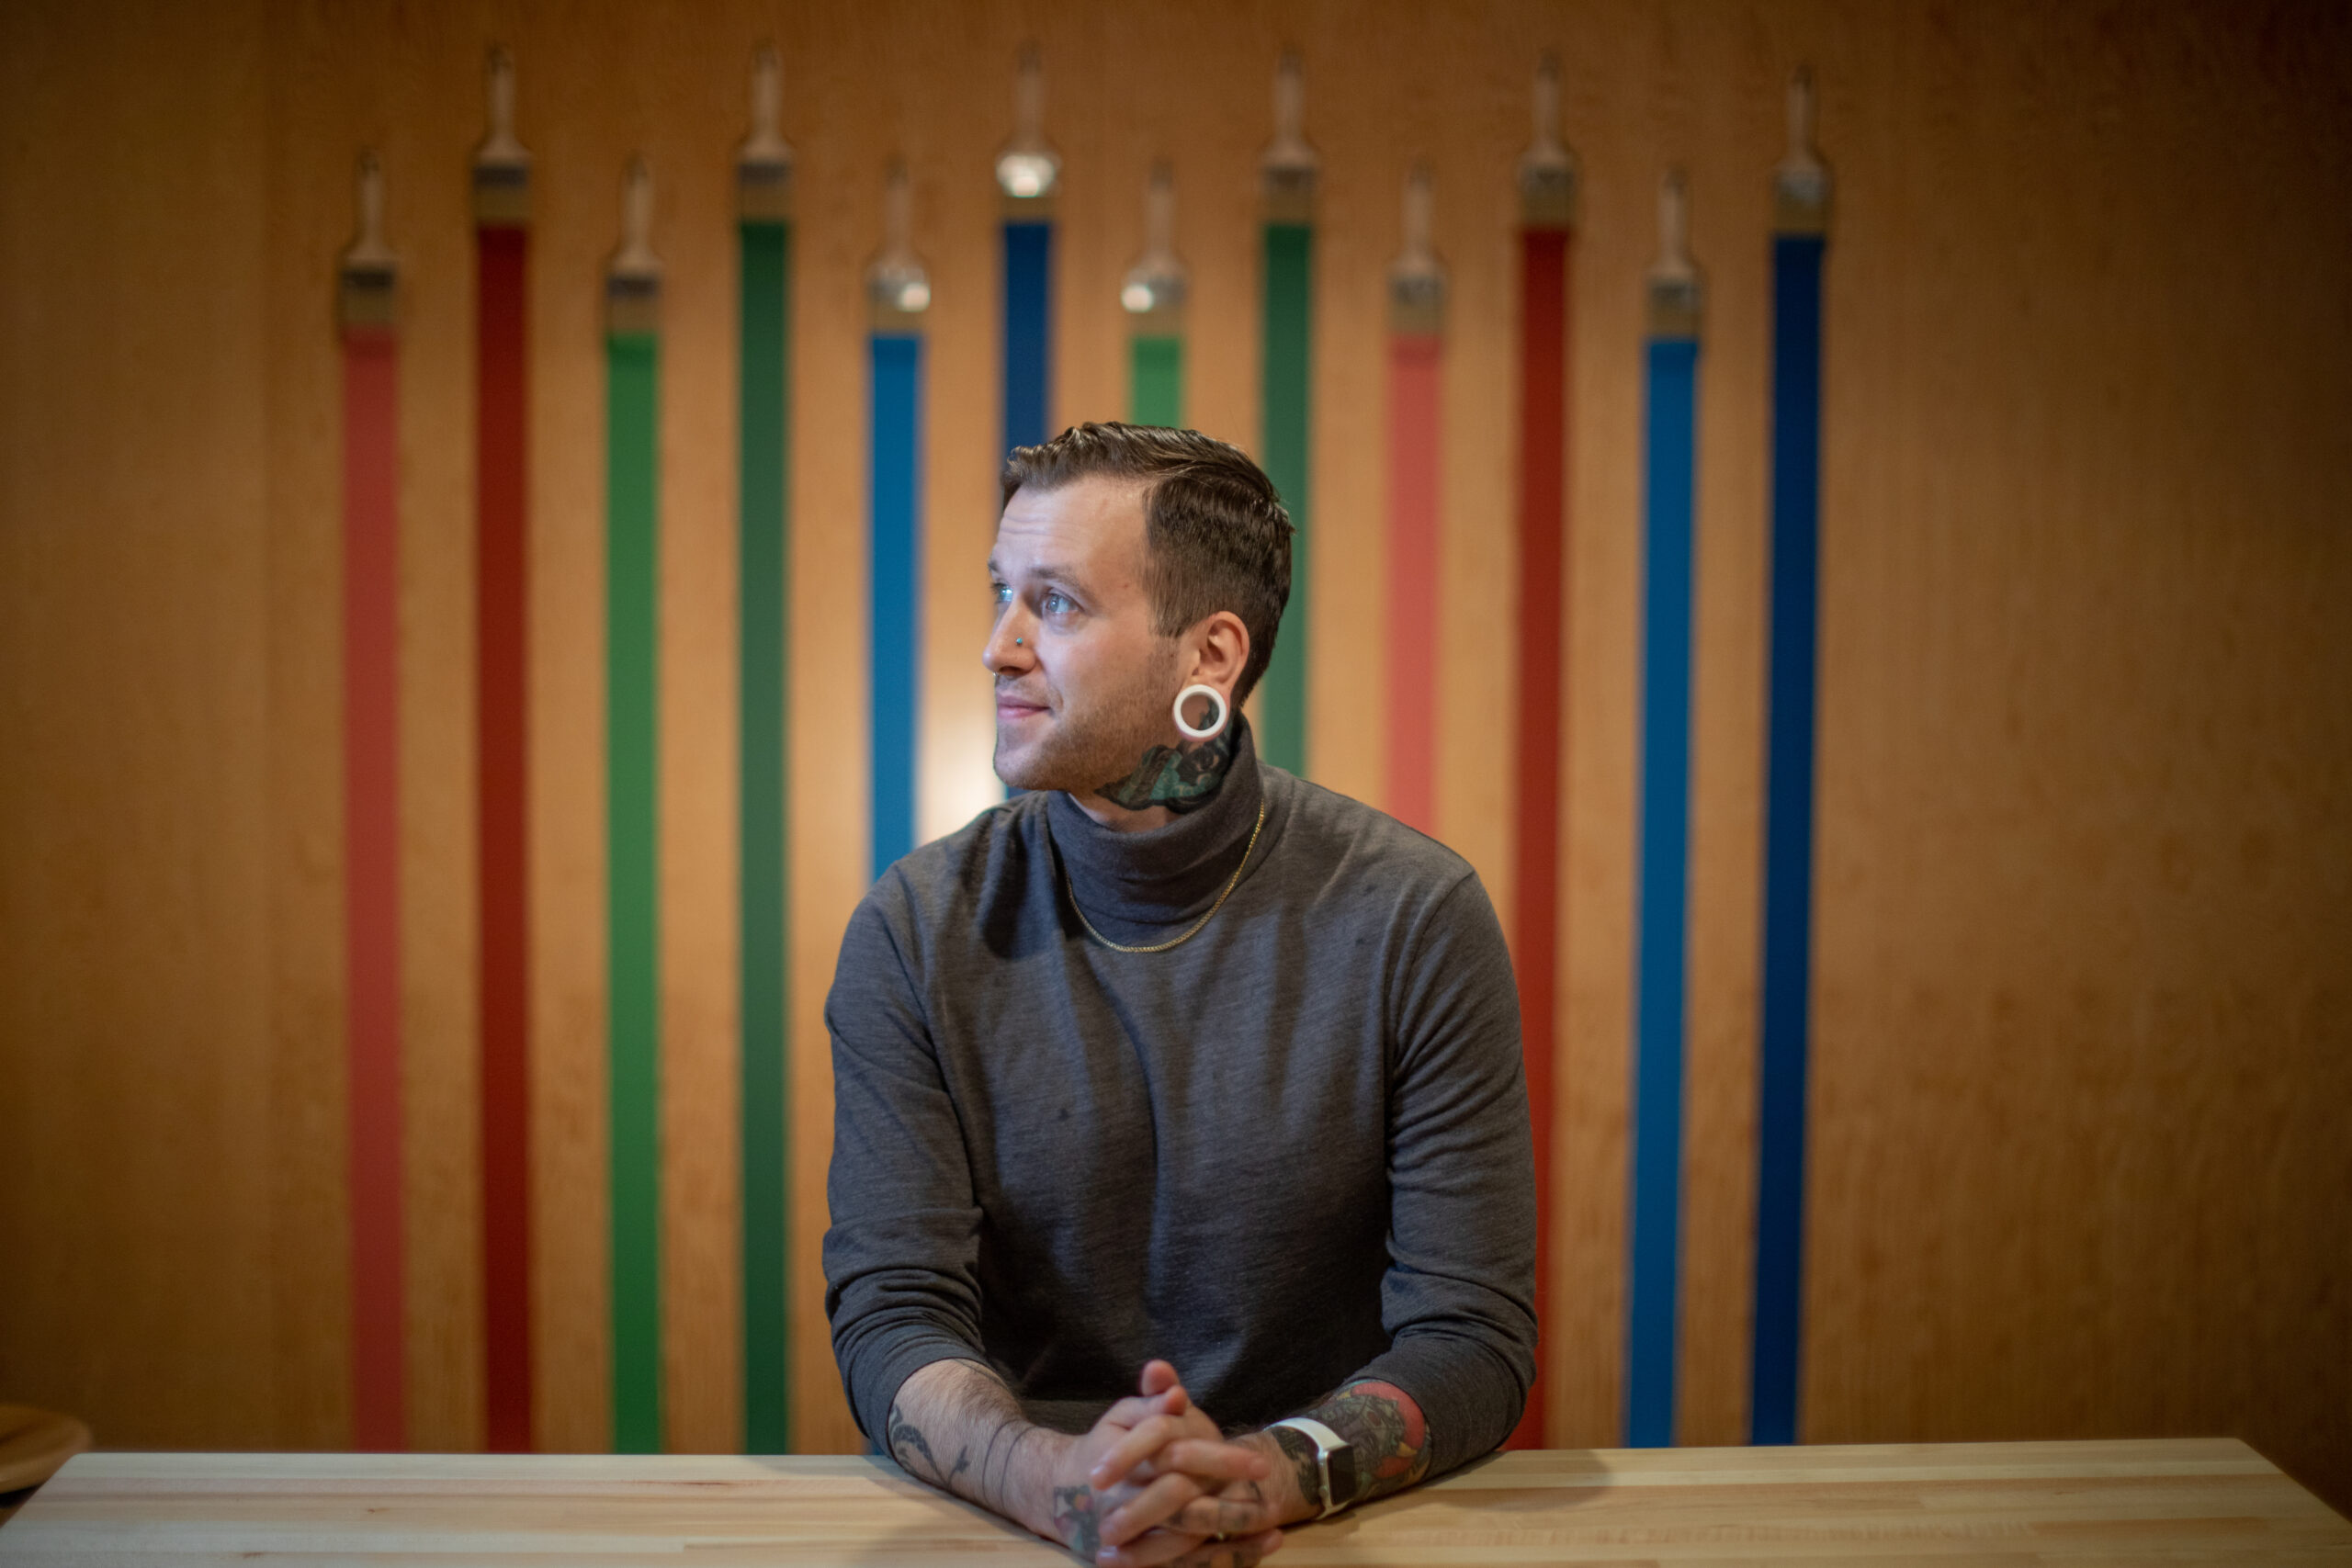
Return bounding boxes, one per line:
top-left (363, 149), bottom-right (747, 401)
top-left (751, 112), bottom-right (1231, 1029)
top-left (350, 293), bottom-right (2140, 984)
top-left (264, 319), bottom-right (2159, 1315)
top-left (1625, 339), bottom-right (1698, 1448)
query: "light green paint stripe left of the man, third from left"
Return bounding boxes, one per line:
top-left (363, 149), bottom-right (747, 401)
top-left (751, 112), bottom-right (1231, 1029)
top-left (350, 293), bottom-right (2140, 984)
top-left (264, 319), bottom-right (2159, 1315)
top-left (605, 333), bottom-right (661, 1453)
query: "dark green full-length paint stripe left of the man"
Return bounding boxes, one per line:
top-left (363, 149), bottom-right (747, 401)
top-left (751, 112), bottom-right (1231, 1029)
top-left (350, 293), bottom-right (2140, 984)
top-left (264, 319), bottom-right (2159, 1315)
top-left (739, 223), bottom-right (793, 1453)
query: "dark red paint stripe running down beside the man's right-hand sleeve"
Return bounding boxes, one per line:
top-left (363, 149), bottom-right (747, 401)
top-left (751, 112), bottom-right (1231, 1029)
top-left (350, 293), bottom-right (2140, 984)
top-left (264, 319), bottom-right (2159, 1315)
top-left (1508, 228), bottom-right (1569, 1448)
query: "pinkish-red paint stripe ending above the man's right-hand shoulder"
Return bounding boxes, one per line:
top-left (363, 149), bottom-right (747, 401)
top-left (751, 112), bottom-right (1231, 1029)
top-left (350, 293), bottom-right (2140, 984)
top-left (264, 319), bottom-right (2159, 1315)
top-left (1387, 332), bottom-right (1444, 837)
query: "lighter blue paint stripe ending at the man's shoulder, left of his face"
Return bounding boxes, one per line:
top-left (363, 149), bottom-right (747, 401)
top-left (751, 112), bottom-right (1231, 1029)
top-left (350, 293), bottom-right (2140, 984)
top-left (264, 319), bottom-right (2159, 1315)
top-left (868, 332), bottom-right (922, 877)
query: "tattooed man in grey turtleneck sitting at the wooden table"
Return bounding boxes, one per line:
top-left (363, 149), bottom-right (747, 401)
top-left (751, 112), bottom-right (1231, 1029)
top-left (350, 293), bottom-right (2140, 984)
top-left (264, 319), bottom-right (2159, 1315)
top-left (826, 425), bottom-right (1536, 1568)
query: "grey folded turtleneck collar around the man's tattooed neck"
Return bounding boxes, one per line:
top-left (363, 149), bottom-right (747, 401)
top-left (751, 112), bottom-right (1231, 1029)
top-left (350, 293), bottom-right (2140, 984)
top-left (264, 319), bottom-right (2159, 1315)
top-left (1046, 715), bottom-right (1265, 926)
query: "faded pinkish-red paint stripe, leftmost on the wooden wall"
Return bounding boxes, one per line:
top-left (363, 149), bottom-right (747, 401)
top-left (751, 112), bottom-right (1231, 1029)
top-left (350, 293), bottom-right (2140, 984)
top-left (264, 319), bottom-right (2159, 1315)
top-left (344, 329), bottom-right (409, 1448)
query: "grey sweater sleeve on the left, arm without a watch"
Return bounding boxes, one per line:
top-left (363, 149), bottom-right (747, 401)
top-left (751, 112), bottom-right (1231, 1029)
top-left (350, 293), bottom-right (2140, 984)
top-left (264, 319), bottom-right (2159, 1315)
top-left (826, 874), bottom-right (986, 1441)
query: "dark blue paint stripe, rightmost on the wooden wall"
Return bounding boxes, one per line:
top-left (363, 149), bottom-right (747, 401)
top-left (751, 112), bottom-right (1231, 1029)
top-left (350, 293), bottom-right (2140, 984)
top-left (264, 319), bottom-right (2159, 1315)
top-left (1747, 235), bottom-right (1823, 1443)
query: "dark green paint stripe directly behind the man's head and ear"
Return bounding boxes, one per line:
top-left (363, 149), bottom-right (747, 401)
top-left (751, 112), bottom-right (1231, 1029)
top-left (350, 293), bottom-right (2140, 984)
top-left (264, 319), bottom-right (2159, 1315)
top-left (1256, 223), bottom-right (1315, 773)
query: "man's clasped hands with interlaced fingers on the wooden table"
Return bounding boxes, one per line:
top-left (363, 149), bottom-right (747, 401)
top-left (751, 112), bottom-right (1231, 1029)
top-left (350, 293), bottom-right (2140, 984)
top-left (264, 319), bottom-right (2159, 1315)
top-left (1054, 1361), bottom-right (1286, 1568)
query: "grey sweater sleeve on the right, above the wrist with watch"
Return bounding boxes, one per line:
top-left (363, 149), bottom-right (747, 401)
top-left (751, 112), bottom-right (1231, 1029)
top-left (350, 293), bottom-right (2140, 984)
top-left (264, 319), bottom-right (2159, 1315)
top-left (1357, 874), bottom-right (1536, 1476)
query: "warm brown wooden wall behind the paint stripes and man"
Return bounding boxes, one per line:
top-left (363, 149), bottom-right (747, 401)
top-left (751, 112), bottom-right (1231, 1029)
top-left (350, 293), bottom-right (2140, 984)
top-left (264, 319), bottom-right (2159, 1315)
top-left (0, 0), bottom-right (2352, 1506)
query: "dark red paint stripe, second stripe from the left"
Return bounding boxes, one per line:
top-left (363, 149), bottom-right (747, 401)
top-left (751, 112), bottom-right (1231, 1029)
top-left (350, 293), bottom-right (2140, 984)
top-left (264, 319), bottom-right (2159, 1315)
top-left (475, 217), bottom-right (532, 1453)
